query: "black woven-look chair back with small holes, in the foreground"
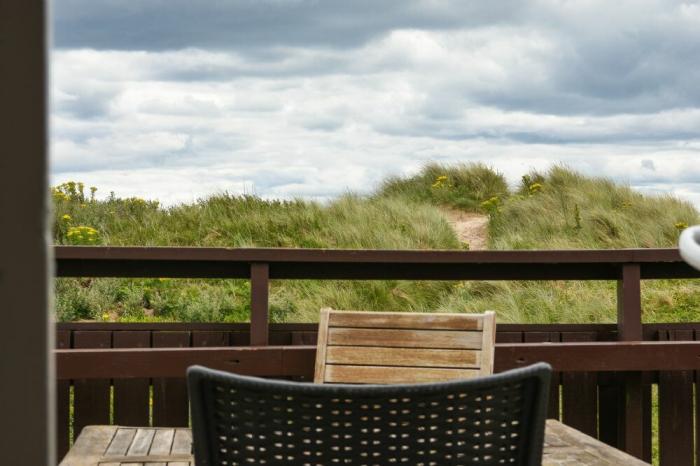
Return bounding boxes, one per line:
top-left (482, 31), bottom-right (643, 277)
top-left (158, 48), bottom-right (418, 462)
top-left (187, 363), bottom-right (551, 466)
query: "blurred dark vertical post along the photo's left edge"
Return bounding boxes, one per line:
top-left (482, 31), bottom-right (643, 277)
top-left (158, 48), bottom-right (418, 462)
top-left (0, 0), bottom-right (56, 466)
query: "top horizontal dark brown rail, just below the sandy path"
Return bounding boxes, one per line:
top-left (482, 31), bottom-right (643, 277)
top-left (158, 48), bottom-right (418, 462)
top-left (54, 246), bottom-right (700, 280)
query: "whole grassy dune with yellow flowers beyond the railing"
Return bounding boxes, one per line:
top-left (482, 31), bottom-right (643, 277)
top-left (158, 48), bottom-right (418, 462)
top-left (53, 164), bottom-right (700, 323)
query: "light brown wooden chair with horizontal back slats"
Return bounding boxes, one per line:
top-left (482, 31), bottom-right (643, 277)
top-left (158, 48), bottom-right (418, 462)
top-left (314, 309), bottom-right (496, 384)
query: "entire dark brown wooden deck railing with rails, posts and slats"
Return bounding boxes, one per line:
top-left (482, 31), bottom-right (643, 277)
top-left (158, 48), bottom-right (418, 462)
top-left (55, 247), bottom-right (700, 465)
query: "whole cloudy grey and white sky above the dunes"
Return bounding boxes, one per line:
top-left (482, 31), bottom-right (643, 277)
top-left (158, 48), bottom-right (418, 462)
top-left (51, 0), bottom-right (700, 207)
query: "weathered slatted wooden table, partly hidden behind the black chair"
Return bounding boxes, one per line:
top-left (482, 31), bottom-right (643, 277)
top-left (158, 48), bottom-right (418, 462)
top-left (60, 419), bottom-right (648, 466)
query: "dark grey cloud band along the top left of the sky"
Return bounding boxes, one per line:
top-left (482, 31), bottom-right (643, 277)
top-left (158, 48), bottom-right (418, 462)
top-left (52, 0), bottom-right (522, 50)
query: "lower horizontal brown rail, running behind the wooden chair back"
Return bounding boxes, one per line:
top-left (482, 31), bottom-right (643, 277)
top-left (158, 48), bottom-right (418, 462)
top-left (55, 341), bottom-right (700, 380)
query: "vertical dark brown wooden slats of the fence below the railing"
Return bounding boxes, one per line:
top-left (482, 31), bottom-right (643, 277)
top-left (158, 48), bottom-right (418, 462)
top-left (57, 323), bottom-right (700, 466)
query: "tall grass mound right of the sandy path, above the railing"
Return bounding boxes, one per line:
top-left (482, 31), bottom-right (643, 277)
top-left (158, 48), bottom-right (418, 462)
top-left (490, 167), bottom-right (698, 249)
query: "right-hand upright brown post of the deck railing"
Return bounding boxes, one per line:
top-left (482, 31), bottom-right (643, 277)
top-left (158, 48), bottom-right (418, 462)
top-left (617, 264), bottom-right (644, 458)
